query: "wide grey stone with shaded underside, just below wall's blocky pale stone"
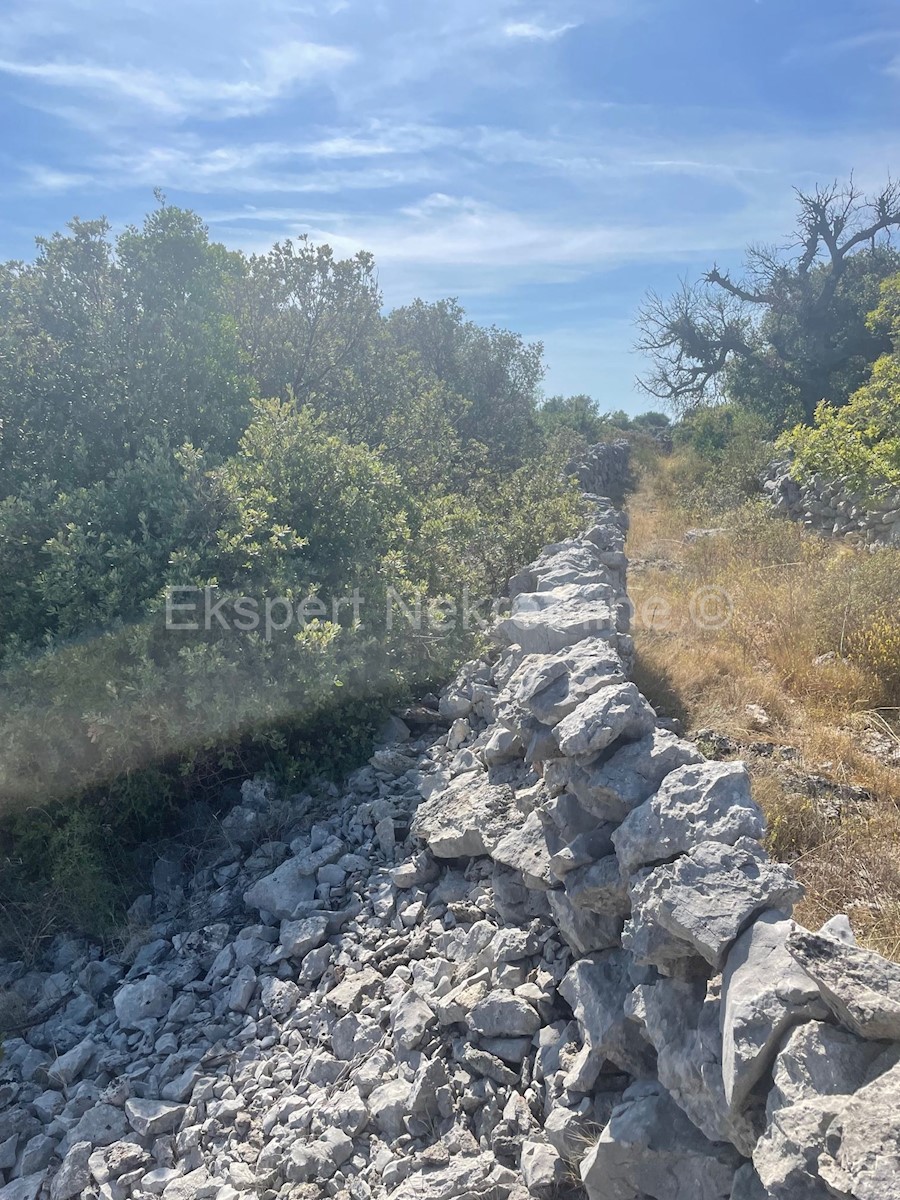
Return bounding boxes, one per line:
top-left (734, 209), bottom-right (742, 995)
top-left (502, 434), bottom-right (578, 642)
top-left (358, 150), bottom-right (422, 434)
top-left (623, 838), bottom-right (803, 973)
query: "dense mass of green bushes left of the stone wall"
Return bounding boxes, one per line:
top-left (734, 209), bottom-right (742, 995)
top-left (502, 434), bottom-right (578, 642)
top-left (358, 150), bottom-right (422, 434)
top-left (0, 202), bottom-right (592, 930)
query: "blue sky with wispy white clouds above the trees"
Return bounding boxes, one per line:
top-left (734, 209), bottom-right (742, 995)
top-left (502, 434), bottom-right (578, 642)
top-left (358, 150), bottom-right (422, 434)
top-left (0, 0), bottom-right (900, 410)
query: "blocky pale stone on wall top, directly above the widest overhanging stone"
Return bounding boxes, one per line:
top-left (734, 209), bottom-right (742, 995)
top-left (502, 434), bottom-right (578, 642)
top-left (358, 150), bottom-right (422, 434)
top-left (612, 762), bottom-right (764, 876)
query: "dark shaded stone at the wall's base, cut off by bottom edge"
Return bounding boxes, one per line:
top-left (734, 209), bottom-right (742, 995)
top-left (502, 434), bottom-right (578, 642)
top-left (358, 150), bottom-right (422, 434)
top-left (581, 1084), bottom-right (740, 1200)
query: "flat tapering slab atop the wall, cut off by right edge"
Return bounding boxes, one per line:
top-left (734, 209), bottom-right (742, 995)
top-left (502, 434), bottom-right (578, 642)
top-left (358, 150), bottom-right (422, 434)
top-left (787, 929), bottom-right (900, 1040)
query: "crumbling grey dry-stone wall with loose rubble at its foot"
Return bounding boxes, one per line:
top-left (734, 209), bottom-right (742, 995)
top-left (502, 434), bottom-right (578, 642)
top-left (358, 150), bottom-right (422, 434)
top-left (0, 487), bottom-right (900, 1200)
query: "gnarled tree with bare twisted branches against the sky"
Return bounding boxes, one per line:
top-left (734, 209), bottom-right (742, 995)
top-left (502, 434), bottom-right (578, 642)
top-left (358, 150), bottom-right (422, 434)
top-left (637, 180), bottom-right (900, 428)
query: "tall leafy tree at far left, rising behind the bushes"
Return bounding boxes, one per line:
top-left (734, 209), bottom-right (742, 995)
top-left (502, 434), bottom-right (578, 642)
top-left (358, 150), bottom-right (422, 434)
top-left (0, 204), bottom-right (251, 496)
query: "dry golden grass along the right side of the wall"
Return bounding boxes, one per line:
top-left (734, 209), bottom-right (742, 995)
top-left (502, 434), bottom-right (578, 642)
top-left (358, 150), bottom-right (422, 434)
top-left (629, 462), bottom-right (900, 959)
